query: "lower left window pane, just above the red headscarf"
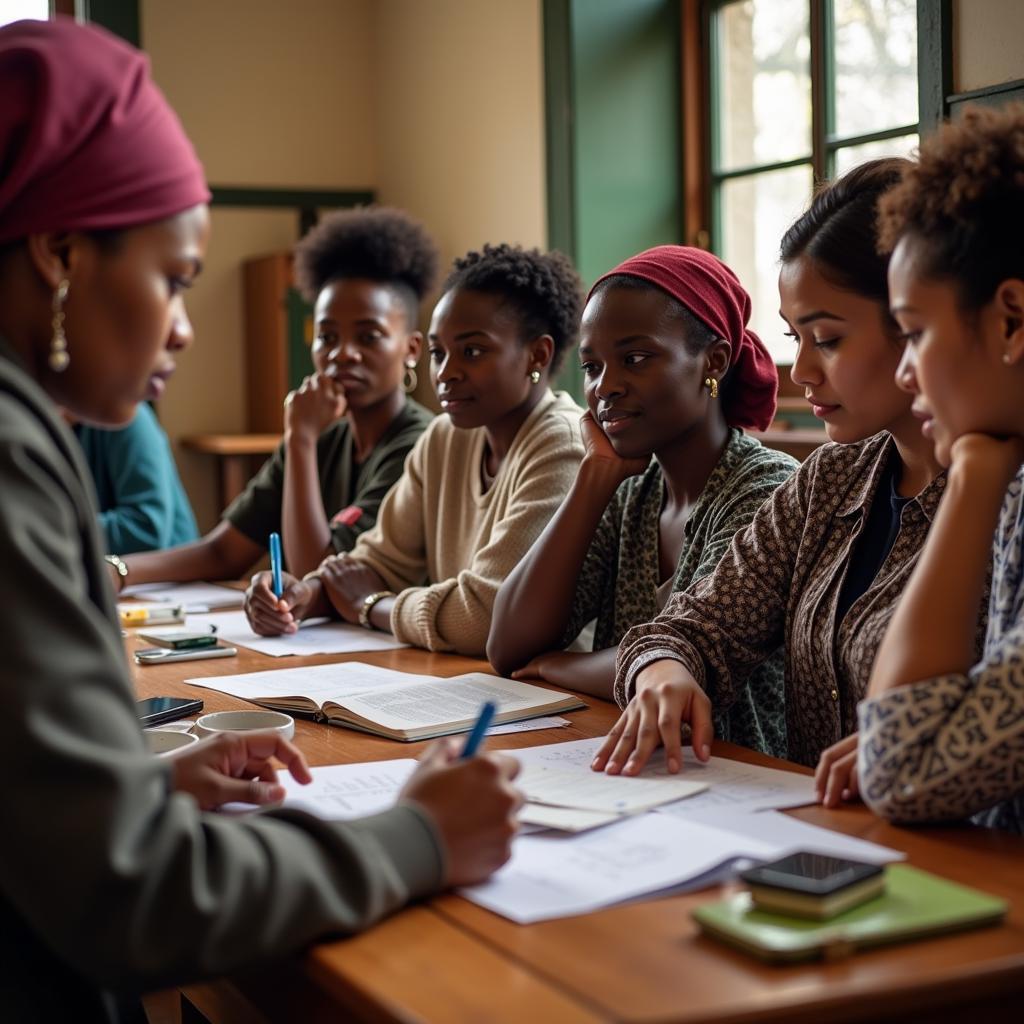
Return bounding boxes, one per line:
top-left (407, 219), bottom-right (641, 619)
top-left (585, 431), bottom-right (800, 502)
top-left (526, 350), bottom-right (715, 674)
top-left (719, 165), bottom-right (811, 362)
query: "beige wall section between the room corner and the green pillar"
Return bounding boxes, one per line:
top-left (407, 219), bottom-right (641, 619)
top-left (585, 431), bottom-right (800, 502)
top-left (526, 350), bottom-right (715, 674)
top-left (374, 0), bottom-right (546, 270)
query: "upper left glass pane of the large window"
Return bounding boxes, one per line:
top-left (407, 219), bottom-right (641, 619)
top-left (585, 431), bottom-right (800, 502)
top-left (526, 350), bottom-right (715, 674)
top-left (713, 0), bottom-right (811, 170)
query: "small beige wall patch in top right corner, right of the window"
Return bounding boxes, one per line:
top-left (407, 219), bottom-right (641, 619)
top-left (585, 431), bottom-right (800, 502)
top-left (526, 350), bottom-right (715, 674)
top-left (953, 0), bottom-right (1024, 92)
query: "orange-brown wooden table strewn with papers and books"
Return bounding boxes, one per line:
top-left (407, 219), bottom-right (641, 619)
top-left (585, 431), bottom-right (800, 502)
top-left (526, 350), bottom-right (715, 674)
top-left (134, 640), bottom-right (1024, 1024)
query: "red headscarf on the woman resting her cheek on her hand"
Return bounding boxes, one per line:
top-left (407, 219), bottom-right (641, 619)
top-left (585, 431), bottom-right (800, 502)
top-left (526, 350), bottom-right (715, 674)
top-left (588, 246), bottom-right (778, 430)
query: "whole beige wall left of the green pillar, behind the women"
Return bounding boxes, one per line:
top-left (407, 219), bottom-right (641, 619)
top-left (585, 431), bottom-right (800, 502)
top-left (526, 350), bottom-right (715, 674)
top-left (140, 0), bottom-right (546, 529)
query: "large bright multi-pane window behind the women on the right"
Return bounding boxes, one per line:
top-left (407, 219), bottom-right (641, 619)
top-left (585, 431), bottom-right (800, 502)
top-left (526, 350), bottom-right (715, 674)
top-left (709, 0), bottom-right (919, 362)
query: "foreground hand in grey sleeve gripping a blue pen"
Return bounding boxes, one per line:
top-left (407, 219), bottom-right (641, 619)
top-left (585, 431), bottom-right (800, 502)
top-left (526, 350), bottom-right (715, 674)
top-left (398, 739), bottom-right (522, 886)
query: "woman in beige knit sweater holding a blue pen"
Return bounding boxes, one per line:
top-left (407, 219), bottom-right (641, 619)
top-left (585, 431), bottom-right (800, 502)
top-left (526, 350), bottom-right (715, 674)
top-left (246, 245), bottom-right (583, 656)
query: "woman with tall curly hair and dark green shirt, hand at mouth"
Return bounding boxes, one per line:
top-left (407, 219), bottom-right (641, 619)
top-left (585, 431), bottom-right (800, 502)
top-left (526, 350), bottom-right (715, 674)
top-left (116, 208), bottom-right (437, 586)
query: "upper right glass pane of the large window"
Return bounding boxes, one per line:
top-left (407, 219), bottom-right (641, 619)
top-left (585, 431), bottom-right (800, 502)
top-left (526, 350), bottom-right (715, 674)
top-left (833, 0), bottom-right (918, 137)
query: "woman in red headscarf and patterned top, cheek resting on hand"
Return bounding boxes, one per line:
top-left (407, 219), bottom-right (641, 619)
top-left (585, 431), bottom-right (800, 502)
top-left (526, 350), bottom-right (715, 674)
top-left (487, 246), bottom-right (797, 754)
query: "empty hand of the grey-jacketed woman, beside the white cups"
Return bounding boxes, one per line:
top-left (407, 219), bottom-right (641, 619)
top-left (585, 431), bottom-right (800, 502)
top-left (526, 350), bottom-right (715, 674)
top-left (167, 732), bottom-right (312, 811)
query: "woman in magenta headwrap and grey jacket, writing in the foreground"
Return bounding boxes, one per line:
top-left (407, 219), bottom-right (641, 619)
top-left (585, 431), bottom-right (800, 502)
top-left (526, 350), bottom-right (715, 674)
top-left (0, 19), bottom-right (517, 1021)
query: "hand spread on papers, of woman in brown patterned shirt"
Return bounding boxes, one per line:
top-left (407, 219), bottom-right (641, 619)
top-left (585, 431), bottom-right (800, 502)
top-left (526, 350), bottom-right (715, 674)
top-left (591, 658), bottom-right (715, 775)
